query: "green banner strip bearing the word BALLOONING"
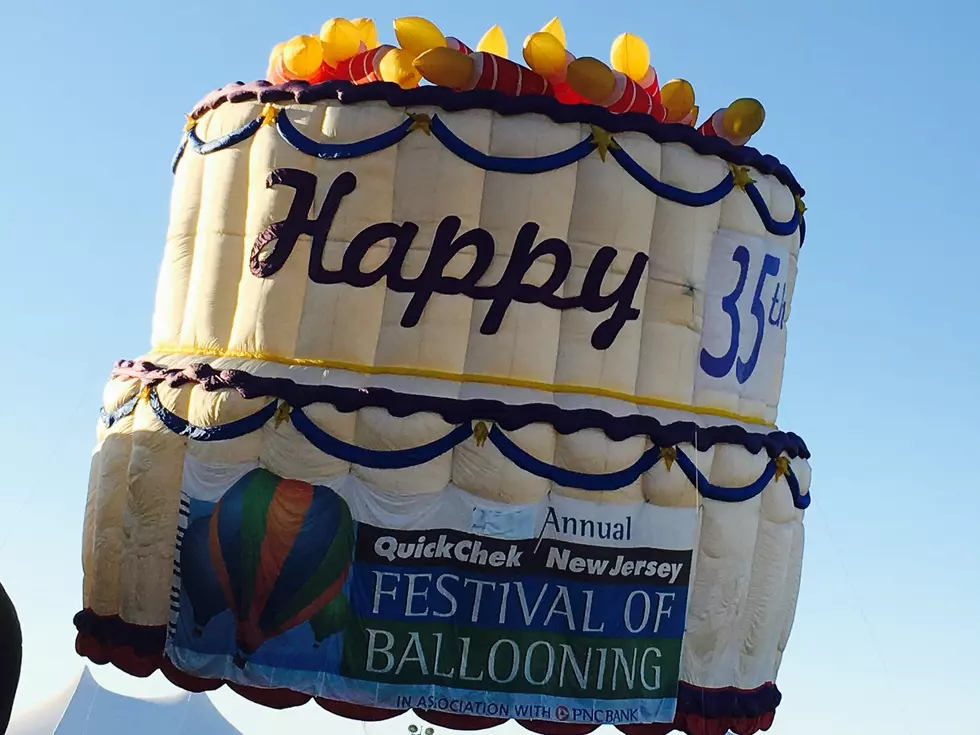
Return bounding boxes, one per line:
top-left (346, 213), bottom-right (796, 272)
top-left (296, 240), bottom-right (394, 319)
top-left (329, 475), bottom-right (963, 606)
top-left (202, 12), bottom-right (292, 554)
top-left (340, 619), bottom-right (681, 700)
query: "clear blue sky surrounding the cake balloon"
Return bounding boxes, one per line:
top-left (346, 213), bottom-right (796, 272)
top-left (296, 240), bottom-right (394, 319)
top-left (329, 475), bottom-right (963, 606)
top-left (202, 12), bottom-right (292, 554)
top-left (0, 0), bottom-right (980, 735)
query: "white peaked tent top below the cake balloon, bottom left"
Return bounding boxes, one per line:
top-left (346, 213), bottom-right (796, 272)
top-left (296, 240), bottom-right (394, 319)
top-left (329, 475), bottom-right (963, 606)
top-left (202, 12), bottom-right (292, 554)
top-left (7, 668), bottom-right (241, 735)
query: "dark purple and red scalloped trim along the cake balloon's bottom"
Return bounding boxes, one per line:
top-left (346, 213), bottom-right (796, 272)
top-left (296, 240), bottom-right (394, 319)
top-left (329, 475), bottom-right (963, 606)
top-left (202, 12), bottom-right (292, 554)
top-left (74, 610), bottom-right (782, 735)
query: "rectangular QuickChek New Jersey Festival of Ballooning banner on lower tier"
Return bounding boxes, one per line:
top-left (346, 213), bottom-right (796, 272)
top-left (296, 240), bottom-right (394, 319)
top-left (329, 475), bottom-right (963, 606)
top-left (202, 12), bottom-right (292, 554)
top-left (167, 458), bottom-right (696, 724)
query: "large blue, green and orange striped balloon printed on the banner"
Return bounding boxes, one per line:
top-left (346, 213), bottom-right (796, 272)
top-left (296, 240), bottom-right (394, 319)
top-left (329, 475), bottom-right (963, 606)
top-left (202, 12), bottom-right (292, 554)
top-left (210, 469), bottom-right (354, 668)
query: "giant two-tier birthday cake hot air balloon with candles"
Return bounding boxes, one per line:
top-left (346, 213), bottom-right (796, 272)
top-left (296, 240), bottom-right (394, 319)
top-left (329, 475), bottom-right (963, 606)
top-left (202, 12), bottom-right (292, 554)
top-left (75, 18), bottom-right (810, 735)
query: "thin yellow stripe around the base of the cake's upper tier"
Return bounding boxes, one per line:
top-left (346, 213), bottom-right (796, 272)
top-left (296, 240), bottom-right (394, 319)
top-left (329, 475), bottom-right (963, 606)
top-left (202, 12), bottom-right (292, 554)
top-left (153, 345), bottom-right (775, 427)
